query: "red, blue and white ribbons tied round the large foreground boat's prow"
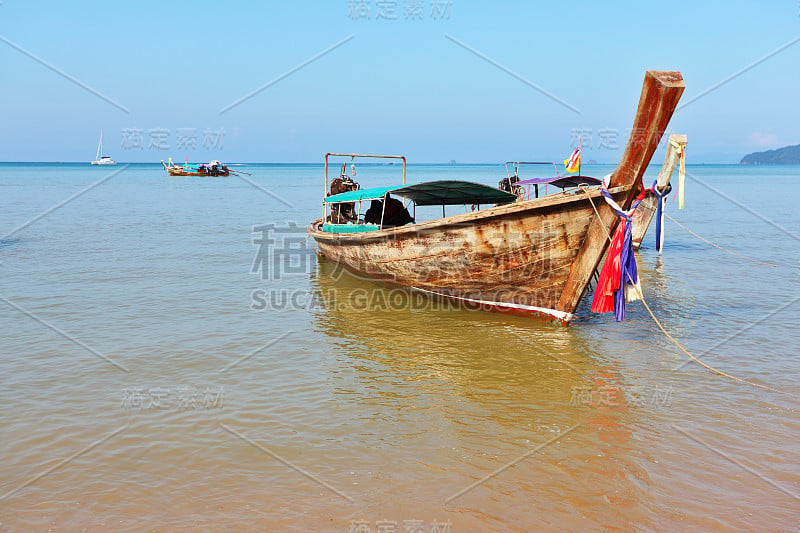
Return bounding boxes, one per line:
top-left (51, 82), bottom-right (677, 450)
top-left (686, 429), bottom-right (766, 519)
top-left (592, 185), bottom-right (645, 322)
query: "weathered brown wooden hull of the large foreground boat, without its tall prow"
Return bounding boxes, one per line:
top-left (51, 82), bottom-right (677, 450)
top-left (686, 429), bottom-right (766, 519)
top-left (308, 188), bottom-right (627, 322)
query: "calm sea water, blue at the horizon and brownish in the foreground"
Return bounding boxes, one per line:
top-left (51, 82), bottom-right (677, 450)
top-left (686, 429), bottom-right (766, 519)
top-left (0, 164), bottom-right (800, 532)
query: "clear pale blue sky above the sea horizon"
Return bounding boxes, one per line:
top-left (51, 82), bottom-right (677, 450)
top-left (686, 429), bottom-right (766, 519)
top-left (0, 0), bottom-right (800, 163)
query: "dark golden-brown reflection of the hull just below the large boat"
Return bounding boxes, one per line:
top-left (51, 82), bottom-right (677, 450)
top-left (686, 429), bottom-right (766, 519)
top-left (312, 257), bottom-right (612, 418)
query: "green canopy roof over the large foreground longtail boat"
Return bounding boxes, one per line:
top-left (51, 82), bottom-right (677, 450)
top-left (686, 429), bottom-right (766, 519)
top-left (325, 180), bottom-right (517, 205)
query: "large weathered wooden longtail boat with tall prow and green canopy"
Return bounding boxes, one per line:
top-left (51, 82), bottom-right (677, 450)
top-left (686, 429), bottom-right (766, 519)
top-left (308, 71), bottom-right (684, 324)
